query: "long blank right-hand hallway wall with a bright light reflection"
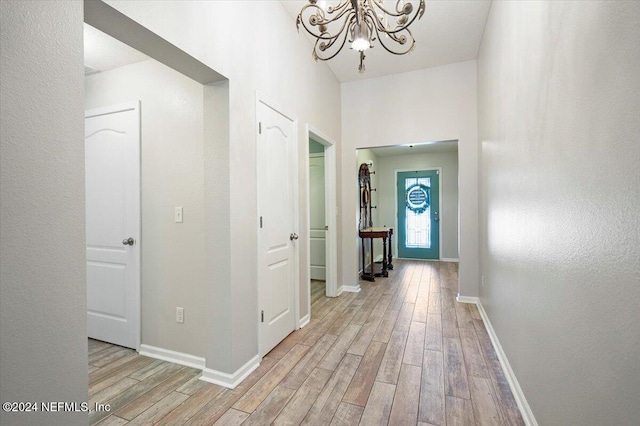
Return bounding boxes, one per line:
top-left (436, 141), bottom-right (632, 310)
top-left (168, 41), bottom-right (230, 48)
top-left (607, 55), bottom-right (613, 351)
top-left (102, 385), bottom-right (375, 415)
top-left (478, 2), bottom-right (640, 425)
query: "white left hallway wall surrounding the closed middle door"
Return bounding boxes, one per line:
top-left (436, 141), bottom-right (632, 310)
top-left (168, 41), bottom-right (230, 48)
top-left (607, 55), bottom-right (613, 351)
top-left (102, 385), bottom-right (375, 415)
top-left (108, 1), bottom-right (342, 373)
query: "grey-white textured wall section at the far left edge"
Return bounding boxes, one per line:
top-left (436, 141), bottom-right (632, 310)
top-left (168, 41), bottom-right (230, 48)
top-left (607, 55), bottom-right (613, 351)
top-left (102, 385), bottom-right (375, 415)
top-left (0, 1), bottom-right (88, 426)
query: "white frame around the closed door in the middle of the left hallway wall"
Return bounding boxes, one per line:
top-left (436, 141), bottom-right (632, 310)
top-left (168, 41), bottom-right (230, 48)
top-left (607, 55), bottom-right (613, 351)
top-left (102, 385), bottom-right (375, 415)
top-left (253, 90), bottom-right (298, 357)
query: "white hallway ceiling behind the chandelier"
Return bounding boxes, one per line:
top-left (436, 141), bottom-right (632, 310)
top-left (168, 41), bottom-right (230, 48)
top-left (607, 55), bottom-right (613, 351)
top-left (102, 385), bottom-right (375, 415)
top-left (282, 0), bottom-right (491, 82)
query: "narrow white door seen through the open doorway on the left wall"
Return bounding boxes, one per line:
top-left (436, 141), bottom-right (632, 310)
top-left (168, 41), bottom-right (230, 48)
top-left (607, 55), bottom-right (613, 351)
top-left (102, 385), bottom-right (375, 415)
top-left (309, 154), bottom-right (327, 281)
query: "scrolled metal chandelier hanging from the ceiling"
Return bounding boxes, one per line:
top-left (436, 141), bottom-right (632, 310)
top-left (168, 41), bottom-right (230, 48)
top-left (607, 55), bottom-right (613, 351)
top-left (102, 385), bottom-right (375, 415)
top-left (296, 0), bottom-right (424, 73)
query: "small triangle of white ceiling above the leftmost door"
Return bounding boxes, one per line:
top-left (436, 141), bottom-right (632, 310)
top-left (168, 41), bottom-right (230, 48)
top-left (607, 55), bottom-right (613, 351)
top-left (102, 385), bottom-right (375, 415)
top-left (84, 24), bottom-right (149, 74)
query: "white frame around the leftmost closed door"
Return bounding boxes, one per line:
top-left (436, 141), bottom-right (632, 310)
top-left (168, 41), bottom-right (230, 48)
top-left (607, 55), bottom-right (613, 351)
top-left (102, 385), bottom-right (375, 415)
top-left (84, 100), bottom-right (142, 352)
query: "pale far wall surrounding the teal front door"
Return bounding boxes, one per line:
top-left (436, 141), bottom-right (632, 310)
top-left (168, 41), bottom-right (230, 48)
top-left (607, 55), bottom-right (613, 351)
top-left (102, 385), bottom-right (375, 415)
top-left (377, 152), bottom-right (458, 259)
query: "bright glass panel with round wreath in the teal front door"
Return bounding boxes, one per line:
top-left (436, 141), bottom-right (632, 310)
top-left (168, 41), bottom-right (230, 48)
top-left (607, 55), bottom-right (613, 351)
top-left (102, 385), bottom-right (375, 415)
top-left (404, 178), bottom-right (431, 249)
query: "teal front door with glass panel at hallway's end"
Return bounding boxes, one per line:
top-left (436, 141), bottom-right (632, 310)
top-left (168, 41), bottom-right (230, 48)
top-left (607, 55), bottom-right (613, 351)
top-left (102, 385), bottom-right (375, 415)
top-left (398, 170), bottom-right (440, 259)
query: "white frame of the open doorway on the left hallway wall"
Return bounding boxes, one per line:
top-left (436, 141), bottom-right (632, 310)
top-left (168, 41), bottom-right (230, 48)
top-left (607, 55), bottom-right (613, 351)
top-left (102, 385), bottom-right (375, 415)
top-left (305, 123), bottom-right (342, 302)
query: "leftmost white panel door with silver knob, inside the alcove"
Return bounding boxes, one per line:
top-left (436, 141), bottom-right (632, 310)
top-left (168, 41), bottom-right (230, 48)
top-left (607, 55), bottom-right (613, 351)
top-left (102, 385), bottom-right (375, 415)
top-left (85, 102), bottom-right (140, 349)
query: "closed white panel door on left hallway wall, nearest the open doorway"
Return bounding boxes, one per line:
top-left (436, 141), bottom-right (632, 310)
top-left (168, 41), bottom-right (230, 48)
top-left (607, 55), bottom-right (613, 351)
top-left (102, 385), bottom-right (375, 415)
top-left (257, 97), bottom-right (298, 355)
